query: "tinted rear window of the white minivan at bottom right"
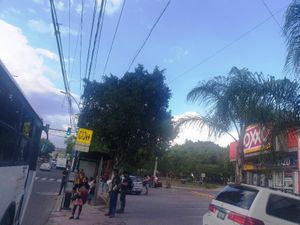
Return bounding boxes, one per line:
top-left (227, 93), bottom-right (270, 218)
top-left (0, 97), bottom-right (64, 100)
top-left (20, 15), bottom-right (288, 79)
top-left (216, 185), bottom-right (258, 209)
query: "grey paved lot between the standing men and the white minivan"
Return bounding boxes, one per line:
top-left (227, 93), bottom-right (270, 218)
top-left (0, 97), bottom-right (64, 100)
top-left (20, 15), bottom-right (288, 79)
top-left (115, 188), bottom-right (211, 225)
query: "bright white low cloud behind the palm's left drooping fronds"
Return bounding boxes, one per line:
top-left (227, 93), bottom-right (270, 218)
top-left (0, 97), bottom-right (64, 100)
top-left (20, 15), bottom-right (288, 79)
top-left (173, 112), bottom-right (237, 147)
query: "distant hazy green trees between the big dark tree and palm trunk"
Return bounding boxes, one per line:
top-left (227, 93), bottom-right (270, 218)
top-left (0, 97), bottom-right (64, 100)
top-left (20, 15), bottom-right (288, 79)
top-left (158, 141), bottom-right (234, 181)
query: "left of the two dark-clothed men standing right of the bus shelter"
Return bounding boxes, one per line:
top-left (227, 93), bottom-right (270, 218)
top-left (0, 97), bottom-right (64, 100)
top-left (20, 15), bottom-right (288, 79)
top-left (105, 169), bottom-right (121, 218)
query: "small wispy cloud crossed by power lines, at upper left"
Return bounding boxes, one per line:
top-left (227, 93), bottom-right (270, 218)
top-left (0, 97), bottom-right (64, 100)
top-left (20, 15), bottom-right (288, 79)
top-left (27, 19), bottom-right (79, 36)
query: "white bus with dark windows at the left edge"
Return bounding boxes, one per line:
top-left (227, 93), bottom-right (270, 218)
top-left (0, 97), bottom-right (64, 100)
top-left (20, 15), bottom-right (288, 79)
top-left (0, 60), bottom-right (44, 225)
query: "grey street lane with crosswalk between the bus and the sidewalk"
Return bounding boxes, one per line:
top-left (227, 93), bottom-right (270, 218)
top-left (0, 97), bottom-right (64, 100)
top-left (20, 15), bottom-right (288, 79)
top-left (22, 169), bottom-right (62, 225)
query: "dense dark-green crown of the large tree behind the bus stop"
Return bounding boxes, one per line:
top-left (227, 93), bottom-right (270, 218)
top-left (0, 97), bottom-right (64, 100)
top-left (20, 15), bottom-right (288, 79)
top-left (79, 65), bottom-right (174, 168)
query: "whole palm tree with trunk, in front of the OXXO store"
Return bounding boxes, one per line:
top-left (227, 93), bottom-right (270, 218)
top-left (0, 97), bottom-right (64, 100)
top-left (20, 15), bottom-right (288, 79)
top-left (177, 67), bottom-right (300, 183)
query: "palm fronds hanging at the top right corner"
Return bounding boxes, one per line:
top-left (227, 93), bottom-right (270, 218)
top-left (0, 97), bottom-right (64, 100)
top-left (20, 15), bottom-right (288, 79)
top-left (283, 0), bottom-right (300, 75)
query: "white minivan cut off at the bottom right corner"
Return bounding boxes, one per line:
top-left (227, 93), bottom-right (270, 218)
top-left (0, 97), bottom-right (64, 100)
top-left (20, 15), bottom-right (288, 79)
top-left (203, 184), bottom-right (300, 225)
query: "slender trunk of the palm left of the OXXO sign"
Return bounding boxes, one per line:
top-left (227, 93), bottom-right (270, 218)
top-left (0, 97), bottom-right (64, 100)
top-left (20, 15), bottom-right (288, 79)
top-left (235, 127), bottom-right (245, 184)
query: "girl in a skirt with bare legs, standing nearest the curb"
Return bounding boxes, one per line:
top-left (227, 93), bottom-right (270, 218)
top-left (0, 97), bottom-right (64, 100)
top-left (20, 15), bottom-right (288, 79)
top-left (69, 183), bottom-right (88, 220)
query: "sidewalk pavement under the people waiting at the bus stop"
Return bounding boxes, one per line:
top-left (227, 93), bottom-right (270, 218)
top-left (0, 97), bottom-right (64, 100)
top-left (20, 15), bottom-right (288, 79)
top-left (46, 201), bottom-right (118, 225)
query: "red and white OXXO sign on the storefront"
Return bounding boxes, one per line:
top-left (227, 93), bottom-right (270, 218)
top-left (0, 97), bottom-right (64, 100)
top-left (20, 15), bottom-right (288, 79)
top-left (244, 125), bottom-right (270, 153)
